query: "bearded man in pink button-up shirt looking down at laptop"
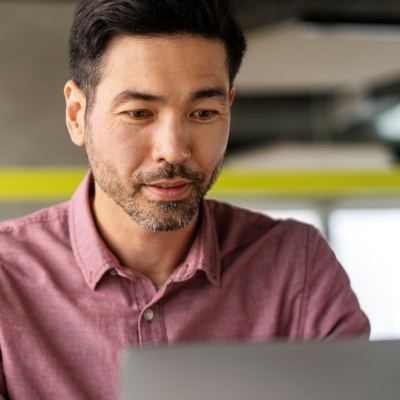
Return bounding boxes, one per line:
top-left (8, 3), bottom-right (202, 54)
top-left (0, 0), bottom-right (369, 400)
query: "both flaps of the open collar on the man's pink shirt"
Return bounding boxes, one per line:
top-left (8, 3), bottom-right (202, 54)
top-left (69, 171), bottom-right (221, 290)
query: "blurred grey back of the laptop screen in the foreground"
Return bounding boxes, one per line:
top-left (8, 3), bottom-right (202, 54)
top-left (120, 340), bottom-right (400, 400)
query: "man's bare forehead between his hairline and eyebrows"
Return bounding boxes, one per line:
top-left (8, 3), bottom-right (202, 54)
top-left (95, 34), bottom-right (229, 94)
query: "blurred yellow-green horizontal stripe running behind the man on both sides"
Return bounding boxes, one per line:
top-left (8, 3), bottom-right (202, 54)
top-left (0, 167), bottom-right (400, 202)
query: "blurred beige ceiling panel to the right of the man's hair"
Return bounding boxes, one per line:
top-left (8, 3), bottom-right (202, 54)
top-left (237, 20), bottom-right (400, 93)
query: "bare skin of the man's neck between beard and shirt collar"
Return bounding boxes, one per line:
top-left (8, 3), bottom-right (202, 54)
top-left (92, 191), bottom-right (198, 286)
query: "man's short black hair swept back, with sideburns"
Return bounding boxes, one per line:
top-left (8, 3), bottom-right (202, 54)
top-left (69, 0), bottom-right (246, 101)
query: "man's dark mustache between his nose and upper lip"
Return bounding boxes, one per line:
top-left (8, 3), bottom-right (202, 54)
top-left (134, 163), bottom-right (205, 187)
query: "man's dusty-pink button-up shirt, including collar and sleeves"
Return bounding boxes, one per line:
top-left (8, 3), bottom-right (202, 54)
top-left (0, 175), bottom-right (369, 400)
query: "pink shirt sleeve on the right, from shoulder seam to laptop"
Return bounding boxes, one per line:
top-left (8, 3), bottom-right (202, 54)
top-left (298, 223), bottom-right (370, 340)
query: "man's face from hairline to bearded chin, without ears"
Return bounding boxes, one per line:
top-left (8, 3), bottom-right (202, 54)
top-left (85, 35), bottom-right (234, 231)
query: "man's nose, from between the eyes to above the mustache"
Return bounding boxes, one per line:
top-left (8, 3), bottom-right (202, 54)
top-left (153, 117), bottom-right (191, 164)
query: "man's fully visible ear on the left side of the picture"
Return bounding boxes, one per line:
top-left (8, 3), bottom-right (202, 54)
top-left (64, 80), bottom-right (86, 146)
